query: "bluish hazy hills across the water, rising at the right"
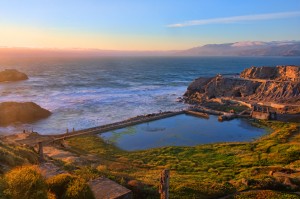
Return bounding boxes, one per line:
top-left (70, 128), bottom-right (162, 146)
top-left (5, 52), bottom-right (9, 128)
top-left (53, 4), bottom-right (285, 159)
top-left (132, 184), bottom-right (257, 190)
top-left (176, 41), bottom-right (300, 56)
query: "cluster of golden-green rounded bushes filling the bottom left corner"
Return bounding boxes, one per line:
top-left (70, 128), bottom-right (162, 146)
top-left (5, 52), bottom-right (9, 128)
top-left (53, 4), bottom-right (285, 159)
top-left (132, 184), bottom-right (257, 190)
top-left (0, 165), bottom-right (94, 199)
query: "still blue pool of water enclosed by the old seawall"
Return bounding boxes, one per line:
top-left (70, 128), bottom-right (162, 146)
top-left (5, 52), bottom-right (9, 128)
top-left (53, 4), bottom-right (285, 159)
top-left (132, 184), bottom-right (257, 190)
top-left (99, 114), bottom-right (266, 151)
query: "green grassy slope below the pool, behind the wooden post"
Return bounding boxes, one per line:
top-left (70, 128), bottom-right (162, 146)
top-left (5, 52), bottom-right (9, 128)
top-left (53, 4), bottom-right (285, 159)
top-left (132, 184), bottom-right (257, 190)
top-left (69, 122), bottom-right (300, 198)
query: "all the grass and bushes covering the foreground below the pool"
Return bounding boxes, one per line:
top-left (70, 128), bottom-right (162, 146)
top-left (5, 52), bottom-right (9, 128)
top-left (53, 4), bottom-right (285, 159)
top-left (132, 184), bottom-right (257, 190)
top-left (0, 121), bottom-right (300, 199)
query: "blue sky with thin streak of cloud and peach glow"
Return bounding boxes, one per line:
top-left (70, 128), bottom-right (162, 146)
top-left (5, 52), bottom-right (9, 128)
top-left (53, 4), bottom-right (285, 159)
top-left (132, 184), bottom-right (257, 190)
top-left (0, 0), bottom-right (300, 51)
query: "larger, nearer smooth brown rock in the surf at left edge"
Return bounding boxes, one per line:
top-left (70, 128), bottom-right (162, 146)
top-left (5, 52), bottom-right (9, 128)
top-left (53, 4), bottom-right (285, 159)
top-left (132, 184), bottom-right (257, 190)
top-left (0, 102), bottom-right (51, 126)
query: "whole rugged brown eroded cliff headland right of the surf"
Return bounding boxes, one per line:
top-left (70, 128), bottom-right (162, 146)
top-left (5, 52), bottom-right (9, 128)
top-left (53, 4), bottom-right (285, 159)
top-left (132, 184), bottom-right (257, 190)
top-left (184, 66), bottom-right (300, 105)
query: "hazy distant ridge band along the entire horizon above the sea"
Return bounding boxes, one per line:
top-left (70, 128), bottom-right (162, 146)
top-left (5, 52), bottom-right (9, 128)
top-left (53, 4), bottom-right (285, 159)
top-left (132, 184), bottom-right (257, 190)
top-left (0, 41), bottom-right (300, 58)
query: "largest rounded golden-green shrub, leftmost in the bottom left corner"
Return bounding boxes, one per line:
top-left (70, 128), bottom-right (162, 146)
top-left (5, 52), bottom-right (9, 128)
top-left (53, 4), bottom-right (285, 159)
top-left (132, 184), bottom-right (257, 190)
top-left (4, 166), bottom-right (47, 199)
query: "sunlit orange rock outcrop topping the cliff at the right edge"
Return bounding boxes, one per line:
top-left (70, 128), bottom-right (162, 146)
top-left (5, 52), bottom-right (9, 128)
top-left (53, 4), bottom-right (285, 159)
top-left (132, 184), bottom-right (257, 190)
top-left (240, 66), bottom-right (300, 81)
